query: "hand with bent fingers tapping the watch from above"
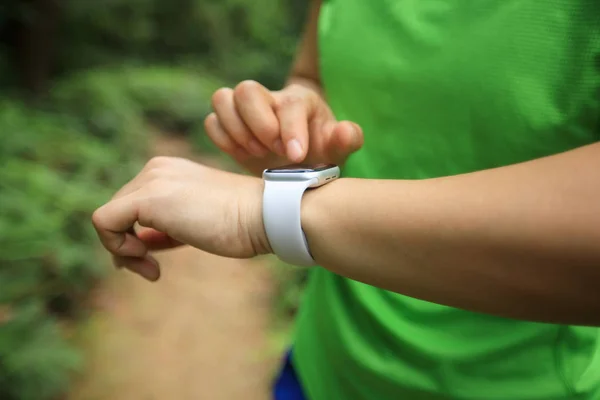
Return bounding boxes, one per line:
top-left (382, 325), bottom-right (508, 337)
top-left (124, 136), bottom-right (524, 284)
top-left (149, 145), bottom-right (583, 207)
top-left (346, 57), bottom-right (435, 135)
top-left (204, 81), bottom-right (363, 172)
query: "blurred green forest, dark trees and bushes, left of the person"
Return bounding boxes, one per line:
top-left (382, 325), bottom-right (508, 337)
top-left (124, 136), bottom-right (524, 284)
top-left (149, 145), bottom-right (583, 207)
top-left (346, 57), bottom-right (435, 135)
top-left (0, 0), bottom-right (307, 400)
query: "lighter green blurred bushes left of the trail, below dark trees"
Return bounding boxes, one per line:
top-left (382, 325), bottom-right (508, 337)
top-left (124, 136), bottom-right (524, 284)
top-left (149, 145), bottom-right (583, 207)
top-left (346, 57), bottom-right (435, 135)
top-left (0, 67), bottom-right (232, 400)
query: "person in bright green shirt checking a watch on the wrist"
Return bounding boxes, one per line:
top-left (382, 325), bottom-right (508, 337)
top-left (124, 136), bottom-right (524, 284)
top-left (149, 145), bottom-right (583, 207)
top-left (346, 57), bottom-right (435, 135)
top-left (93, 0), bottom-right (600, 400)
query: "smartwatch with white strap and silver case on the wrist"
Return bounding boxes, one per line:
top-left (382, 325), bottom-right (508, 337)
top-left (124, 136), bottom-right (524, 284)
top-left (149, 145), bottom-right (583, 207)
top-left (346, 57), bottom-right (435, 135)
top-left (263, 164), bottom-right (340, 267)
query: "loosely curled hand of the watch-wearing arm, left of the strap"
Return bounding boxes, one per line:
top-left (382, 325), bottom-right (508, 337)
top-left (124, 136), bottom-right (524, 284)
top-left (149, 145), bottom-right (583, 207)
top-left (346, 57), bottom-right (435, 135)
top-left (92, 157), bottom-right (269, 281)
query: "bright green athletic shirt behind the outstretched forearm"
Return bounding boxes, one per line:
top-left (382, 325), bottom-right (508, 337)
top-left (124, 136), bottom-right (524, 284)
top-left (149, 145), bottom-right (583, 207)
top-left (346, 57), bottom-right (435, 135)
top-left (293, 0), bottom-right (600, 400)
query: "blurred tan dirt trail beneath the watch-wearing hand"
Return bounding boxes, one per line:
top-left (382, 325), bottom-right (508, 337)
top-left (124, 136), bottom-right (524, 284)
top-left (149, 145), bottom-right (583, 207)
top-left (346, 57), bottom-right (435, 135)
top-left (69, 137), bottom-right (280, 400)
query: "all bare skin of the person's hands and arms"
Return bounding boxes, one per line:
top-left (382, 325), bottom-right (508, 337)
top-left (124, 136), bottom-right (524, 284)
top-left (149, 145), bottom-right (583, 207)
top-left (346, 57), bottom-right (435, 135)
top-left (92, 3), bottom-right (600, 326)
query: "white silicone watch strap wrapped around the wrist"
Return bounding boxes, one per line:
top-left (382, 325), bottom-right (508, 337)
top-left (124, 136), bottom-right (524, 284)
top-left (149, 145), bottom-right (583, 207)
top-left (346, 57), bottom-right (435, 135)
top-left (263, 179), bottom-right (316, 267)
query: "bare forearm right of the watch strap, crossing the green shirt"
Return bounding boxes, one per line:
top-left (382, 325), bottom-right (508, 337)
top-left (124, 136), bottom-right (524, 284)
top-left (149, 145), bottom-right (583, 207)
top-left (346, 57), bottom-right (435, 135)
top-left (302, 143), bottom-right (600, 326)
